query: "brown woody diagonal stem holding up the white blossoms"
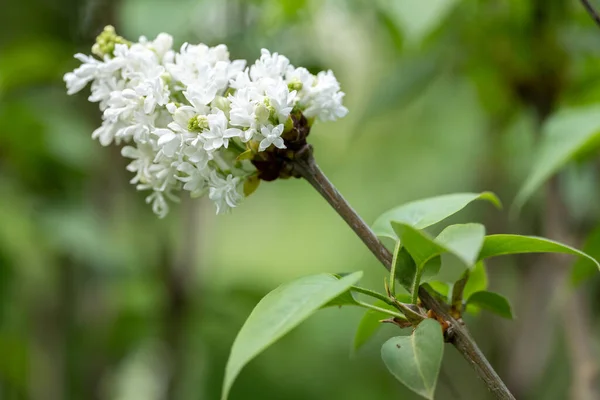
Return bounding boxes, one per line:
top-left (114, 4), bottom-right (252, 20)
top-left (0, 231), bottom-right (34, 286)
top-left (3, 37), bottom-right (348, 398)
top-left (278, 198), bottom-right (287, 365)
top-left (292, 153), bottom-right (514, 400)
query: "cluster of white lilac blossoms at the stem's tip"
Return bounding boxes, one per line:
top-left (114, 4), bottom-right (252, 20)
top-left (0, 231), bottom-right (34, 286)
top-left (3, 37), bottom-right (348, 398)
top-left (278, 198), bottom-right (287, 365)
top-left (64, 26), bottom-right (348, 217)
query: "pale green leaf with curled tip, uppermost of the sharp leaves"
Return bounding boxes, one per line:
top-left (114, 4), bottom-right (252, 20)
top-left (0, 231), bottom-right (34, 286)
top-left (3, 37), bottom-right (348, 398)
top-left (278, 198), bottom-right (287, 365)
top-left (373, 192), bottom-right (502, 240)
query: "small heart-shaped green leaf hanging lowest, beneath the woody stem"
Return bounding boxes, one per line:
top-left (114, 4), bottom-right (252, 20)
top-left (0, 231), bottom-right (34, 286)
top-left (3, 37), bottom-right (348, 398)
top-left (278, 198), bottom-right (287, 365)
top-left (381, 319), bottom-right (444, 399)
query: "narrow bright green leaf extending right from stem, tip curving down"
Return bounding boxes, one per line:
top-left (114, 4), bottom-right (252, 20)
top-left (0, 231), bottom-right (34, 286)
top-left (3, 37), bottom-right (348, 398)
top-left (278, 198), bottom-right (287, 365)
top-left (479, 235), bottom-right (600, 269)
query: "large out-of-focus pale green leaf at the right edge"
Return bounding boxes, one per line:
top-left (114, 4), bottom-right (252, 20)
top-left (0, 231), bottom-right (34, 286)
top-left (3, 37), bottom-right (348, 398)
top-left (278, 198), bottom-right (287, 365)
top-left (513, 105), bottom-right (600, 210)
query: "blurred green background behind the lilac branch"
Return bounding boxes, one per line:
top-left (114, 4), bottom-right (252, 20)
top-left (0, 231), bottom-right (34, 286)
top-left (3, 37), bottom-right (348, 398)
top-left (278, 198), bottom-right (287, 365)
top-left (0, 0), bottom-right (600, 400)
